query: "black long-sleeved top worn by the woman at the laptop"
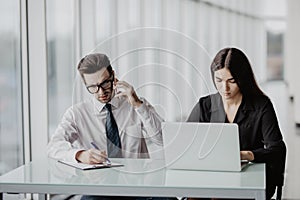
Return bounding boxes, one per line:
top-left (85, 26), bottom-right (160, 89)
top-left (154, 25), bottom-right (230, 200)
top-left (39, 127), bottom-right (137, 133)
top-left (187, 93), bottom-right (285, 163)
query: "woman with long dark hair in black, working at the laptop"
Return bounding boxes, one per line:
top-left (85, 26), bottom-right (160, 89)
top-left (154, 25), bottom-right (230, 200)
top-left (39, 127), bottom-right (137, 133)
top-left (188, 48), bottom-right (286, 199)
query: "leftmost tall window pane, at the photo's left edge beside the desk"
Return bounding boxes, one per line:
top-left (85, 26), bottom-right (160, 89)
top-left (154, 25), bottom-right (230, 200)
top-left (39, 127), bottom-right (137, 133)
top-left (0, 0), bottom-right (23, 175)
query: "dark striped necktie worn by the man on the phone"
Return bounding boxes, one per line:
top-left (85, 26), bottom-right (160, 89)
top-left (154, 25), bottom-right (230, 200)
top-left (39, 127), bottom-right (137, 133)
top-left (105, 104), bottom-right (122, 158)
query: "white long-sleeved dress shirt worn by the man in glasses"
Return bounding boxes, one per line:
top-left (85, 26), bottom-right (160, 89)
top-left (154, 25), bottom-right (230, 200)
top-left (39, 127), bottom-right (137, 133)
top-left (47, 97), bottom-right (163, 161)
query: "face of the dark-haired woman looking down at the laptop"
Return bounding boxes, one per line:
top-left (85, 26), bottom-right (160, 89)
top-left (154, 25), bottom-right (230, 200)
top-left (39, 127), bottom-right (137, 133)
top-left (214, 67), bottom-right (242, 100)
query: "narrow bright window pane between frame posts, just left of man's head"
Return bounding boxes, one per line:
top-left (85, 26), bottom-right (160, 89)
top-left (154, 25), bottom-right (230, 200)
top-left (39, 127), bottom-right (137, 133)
top-left (46, 0), bottom-right (76, 135)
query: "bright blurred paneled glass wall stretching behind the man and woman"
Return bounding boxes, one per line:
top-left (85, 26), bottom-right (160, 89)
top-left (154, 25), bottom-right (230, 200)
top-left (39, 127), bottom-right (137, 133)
top-left (46, 0), bottom-right (266, 135)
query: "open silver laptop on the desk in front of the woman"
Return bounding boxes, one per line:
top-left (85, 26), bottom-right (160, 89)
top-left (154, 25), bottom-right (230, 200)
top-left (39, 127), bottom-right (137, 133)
top-left (162, 122), bottom-right (248, 172)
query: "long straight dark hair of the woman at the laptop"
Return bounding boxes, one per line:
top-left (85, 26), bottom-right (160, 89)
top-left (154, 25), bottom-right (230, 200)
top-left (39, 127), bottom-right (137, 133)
top-left (210, 48), bottom-right (264, 97)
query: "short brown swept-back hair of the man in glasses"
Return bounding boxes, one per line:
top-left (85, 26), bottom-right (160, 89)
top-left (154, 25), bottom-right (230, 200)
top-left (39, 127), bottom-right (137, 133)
top-left (77, 53), bottom-right (112, 82)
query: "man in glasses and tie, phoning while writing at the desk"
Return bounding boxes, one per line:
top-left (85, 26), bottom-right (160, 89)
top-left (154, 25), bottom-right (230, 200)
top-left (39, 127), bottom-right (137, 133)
top-left (48, 53), bottom-right (173, 199)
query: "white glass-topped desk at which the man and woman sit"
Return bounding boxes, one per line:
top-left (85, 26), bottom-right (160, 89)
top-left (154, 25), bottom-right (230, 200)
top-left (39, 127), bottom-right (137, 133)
top-left (0, 159), bottom-right (265, 200)
